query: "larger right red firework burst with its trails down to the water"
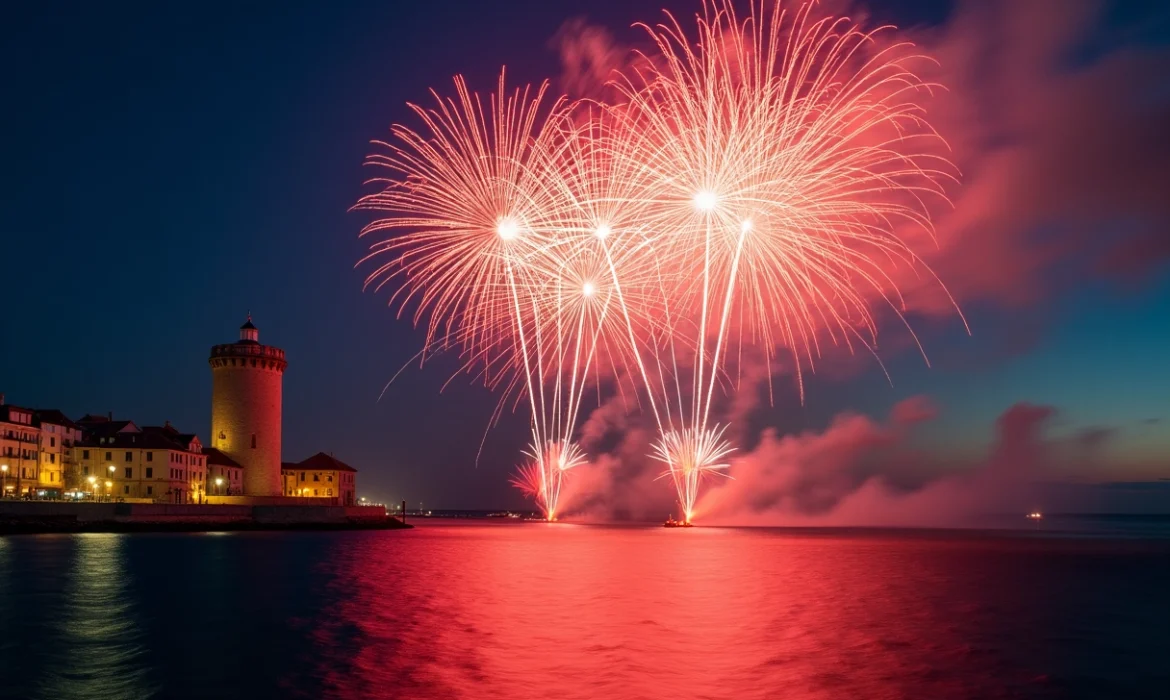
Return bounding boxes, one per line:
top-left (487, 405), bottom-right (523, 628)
top-left (611, 0), bottom-right (950, 521)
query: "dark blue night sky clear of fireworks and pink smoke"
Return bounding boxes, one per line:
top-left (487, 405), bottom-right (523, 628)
top-left (0, 0), bottom-right (1170, 507)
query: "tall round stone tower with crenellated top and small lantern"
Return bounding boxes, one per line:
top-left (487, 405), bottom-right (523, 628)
top-left (207, 314), bottom-right (288, 496)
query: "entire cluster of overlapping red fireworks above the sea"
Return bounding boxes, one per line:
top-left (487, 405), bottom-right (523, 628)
top-left (357, 0), bottom-right (957, 523)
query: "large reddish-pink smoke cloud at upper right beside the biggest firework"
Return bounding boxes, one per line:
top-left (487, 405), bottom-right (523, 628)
top-left (917, 0), bottom-right (1170, 311)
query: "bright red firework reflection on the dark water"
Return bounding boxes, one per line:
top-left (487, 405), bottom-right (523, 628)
top-left (299, 523), bottom-right (1026, 700)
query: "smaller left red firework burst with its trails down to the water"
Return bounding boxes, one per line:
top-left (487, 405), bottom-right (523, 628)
top-left (357, 75), bottom-right (613, 520)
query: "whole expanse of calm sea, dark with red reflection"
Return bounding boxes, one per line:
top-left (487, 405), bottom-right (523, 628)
top-left (0, 521), bottom-right (1170, 700)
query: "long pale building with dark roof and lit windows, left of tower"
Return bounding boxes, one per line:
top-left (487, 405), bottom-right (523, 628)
top-left (73, 420), bottom-right (207, 503)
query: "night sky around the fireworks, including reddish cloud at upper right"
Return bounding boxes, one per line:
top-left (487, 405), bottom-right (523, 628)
top-left (0, 0), bottom-right (1170, 508)
